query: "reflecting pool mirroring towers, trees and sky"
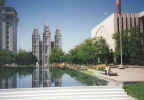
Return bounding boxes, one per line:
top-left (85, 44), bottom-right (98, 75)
top-left (0, 67), bottom-right (107, 89)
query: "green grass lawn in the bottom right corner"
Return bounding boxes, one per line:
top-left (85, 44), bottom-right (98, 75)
top-left (124, 82), bottom-right (144, 100)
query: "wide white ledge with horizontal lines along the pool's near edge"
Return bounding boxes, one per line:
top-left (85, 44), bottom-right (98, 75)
top-left (0, 86), bottom-right (133, 100)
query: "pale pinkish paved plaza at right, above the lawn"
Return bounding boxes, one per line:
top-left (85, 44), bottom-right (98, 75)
top-left (90, 68), bottom-right (144, 83)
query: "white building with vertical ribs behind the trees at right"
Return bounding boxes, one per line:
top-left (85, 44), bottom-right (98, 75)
top-left (91, 11), bottom-right (144, 51)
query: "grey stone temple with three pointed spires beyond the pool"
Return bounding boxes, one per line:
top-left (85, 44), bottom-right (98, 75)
top-left (32, 24), bottom-right (62, 67)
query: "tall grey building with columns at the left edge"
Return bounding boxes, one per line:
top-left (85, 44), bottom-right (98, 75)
top-left (0, 0), bottom-right (18, 52)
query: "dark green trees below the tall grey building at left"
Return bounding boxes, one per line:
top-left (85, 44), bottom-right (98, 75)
top-left (0, 50), bottom-right (36, 65)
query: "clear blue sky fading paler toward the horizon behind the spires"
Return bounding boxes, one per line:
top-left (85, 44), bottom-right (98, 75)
top-left (6, 0), bottom-right (144, 52)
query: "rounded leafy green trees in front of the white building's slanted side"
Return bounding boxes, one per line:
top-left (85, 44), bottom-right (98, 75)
top-left (65, 38), bottom-right (110, 64)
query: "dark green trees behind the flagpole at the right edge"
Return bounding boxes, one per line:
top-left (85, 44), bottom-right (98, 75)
top-left (113, 27), bottom-right (144, 64)
